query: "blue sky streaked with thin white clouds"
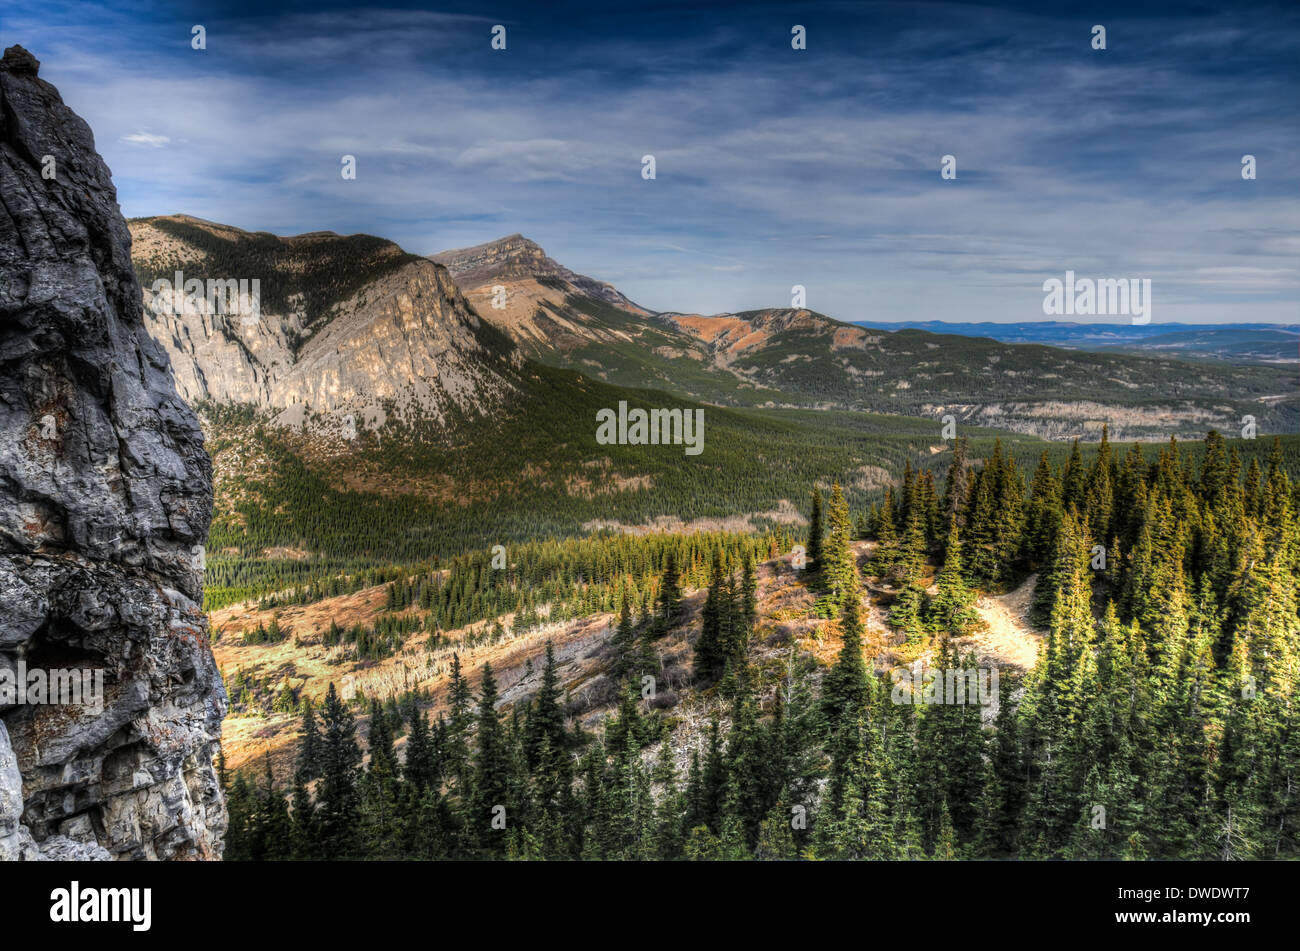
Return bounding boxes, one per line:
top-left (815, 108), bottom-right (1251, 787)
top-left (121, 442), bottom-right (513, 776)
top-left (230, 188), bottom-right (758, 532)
top-left (0, 0), bottom-right (1300, 323)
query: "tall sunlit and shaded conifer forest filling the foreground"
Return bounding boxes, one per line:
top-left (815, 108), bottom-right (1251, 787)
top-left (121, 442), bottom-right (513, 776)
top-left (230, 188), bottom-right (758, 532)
top-left (222, 433), bottom-right (1300, 860)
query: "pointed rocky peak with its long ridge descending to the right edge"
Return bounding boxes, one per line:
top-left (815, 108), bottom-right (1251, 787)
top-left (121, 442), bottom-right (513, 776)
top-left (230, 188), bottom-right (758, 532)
top-left (434, 235), bottom-right (1300, 439)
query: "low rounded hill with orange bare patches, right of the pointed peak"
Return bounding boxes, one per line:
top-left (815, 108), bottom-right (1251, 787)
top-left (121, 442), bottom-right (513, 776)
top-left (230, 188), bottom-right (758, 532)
top-left (660, 309), bottom-right (1300, 440)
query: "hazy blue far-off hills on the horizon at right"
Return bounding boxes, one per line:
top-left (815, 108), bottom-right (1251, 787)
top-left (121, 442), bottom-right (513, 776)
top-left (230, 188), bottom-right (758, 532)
top-left (859, 321), bottom-right (1300, 364)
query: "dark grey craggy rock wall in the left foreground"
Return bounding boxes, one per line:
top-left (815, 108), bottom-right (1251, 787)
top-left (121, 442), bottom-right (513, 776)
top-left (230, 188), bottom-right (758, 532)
top-left (0, 47), bottom-right (226, 859)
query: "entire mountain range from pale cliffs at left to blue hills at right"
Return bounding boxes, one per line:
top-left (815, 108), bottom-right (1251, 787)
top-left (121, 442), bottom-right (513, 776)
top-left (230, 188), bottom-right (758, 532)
top-left (131, 216), bottom-right (1300, 439)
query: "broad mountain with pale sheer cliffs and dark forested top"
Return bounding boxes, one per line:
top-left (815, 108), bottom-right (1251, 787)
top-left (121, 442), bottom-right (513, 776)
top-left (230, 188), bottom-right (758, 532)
top-left (130, 216), bottom-right (521, 426)
